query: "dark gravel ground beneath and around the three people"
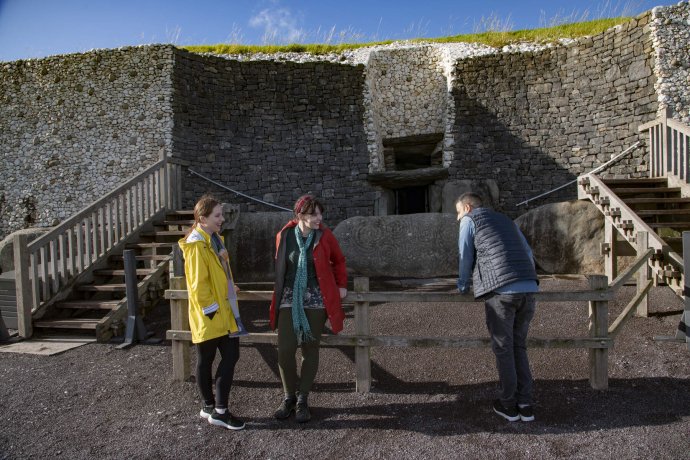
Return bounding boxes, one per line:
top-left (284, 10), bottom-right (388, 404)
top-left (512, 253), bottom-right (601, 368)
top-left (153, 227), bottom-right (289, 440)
top-left (0, 280), bottom-right (690, 460)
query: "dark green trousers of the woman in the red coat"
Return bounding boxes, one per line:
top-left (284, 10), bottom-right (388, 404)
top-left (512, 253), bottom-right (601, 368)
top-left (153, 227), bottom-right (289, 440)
top-left (278, 308), bottom-right (326, 396)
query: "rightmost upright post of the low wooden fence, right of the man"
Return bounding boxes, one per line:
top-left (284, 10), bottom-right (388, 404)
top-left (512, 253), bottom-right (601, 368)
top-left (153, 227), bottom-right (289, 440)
top-left (589, 275), bottom-right (609, 390)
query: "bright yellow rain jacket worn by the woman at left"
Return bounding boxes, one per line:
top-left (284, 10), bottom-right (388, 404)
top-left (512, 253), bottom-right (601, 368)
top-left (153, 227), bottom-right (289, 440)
top-left (178, 226), bottom-right (237, 343)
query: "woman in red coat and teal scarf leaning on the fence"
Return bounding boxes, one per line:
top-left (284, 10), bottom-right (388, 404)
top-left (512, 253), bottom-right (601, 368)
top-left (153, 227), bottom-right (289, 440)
top-left (270, 195), bottom-right (347, 423)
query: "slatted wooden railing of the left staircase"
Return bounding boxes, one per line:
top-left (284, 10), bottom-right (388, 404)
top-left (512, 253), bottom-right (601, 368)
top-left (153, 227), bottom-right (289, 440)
top-left (14, 157), bottom-right (181, 337)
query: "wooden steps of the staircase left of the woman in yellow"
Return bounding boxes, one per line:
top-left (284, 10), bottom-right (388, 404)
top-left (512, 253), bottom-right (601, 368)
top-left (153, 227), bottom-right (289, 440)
top-left (33, 211), bottom-right (193, 341)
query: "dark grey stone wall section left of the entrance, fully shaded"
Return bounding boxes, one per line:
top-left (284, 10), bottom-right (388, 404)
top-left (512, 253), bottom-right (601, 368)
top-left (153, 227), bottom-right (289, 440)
top-left (173, 50), bottom-right (375, 225)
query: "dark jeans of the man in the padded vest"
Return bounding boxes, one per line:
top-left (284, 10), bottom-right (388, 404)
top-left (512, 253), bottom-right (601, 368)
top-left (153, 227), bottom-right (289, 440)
top-left (484, 293), bottom-right (536, 408)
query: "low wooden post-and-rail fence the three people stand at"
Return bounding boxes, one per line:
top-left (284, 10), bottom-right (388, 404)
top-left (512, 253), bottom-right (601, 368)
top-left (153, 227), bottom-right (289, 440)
top-left (165, 249), bottom-right (653, 392)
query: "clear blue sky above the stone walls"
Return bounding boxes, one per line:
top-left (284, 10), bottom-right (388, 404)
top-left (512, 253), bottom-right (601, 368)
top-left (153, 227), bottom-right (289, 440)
top-left (0, 0), bottom-right (677, 61)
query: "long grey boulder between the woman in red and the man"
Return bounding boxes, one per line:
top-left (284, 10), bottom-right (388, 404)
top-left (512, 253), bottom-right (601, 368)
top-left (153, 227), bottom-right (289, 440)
top-left (333, 213), bottom-right (458, 278)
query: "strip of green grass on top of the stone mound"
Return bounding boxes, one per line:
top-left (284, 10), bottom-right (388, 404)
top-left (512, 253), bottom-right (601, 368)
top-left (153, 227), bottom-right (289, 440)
top-left (181, 17), bottom-right (631, 54)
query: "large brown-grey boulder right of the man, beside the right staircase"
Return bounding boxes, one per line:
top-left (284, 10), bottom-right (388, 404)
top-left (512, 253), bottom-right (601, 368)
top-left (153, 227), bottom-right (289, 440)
top-left (515, 201), bottom-right (604, 274)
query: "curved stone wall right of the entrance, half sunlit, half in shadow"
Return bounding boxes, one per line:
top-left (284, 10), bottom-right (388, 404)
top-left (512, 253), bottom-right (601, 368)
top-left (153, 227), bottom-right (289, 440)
top-left (451, 14), bottom-right (658, 215)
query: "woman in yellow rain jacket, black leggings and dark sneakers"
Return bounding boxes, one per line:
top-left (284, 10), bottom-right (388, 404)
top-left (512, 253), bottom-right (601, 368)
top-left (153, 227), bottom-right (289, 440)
top-left (178, 196), bottom-right (246, 430)
